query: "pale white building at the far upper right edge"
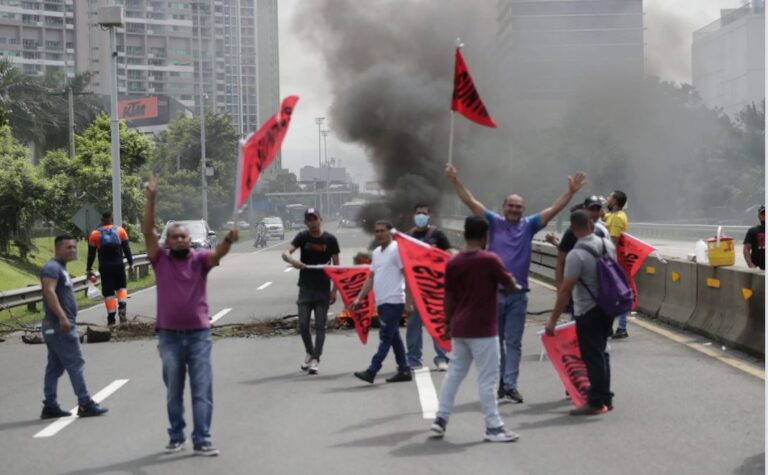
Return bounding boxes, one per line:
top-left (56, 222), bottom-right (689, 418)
top-left (691, 1), bottom-right (765, 117)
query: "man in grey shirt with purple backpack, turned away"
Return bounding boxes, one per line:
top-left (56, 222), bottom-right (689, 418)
top-left (545, 210), bottom-right (632, 416)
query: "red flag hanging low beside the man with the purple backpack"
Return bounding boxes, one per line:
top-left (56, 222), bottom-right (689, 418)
top-left (540, 322), bottom-right (590, 407)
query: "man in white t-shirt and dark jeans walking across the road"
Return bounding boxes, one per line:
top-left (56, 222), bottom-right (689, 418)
top-left (352, 221), bottom-right (412, 384)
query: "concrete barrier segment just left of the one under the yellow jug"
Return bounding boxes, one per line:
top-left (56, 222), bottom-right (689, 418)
top-left (658, 259), bottom-right (698, 328)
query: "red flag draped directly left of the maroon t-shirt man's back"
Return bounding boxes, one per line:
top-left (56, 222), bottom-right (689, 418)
top-left (395, 232), bottom-right (451, 352)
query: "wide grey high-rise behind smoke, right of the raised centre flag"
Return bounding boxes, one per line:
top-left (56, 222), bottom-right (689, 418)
top-left (497, 0), bottom-right (645, 126)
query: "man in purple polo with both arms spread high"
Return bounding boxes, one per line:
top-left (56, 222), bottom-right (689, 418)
top-left (445, 164), bottom-right (587, 403)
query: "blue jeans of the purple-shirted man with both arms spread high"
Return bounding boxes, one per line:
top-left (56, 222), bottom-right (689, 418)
top-left (499, 293), bottom-right (528, 389)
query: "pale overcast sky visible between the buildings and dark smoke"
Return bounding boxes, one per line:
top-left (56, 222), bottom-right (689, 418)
top-left (278, 0), bottom-right (745, 182)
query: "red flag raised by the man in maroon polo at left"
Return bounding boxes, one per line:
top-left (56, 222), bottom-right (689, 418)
top-left (235, 96), bottom-right (299, 209)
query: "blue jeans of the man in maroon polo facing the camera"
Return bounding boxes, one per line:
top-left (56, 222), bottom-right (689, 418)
top-left (157, 329), bottom-right (213, 445)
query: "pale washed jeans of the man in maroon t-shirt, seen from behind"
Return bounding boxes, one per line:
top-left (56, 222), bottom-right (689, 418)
top-left (436, 336), bottom-right (504, 429)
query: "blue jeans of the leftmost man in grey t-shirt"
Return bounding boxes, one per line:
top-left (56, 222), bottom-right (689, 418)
top-left (43, 322), bottom-right (91, 407)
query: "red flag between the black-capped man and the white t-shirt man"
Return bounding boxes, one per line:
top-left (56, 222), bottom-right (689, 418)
top-left (323, 266), bottom-right (376, 345)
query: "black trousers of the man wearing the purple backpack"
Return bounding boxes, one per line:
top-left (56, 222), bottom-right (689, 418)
top-left (576, 307), bottom-right (613, 408)
